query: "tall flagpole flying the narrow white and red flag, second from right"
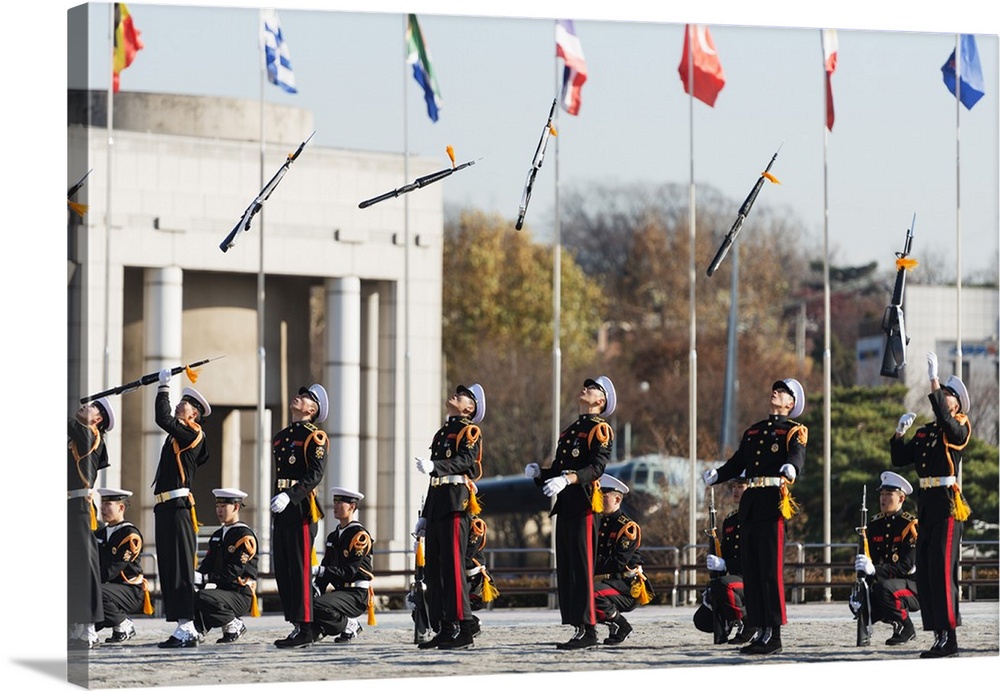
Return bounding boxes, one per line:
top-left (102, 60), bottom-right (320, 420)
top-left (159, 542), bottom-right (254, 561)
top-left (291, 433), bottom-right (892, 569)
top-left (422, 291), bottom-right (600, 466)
top-left (820, 29), bottom-right (832, 602)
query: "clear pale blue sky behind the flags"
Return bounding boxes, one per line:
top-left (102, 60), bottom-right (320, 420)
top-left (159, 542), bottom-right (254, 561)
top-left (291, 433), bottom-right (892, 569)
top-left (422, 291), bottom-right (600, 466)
top-left (74, 1), bottom-right (1000, 276)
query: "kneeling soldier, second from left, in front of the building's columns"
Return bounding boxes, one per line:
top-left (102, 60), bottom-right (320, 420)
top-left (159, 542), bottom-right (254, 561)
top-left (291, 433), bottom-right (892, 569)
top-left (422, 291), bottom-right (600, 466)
top-left (194, 487), bottom-right (260, 643)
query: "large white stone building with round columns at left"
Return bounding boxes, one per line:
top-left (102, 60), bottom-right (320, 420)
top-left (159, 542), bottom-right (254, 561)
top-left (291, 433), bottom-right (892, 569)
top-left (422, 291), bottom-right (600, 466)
top-left (67, 90), bottom-right (443, 570)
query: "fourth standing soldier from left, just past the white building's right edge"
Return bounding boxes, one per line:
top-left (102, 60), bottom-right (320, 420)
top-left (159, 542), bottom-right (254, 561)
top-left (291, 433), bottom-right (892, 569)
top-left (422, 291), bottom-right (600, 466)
top-left (413, 384), bottom-right (486, 650)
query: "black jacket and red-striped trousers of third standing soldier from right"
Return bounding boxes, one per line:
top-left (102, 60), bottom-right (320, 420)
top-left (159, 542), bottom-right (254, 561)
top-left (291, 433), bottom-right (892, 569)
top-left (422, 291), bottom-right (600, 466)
top-left (535, 414), bottom-right (614, 626)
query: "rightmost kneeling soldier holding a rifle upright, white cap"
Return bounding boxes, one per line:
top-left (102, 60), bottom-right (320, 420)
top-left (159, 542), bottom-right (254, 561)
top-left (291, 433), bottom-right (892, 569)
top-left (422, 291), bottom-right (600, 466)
top-left (851, 470), bottom-right (920, 645)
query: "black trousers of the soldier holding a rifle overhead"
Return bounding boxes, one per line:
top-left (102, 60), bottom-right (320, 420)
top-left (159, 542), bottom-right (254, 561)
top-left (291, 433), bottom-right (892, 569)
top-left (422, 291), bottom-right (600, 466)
top-left (153, 497), bottom-right (198, 621)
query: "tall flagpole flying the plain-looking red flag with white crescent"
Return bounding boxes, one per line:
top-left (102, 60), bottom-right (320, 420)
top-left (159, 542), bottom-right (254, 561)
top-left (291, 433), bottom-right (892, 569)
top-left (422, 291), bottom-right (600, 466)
top-left (685, 24), bottom-right (698, 597)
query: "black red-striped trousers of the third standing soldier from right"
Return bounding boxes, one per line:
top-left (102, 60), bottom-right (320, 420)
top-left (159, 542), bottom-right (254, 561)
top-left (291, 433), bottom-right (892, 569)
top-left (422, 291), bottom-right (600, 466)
top-left (555, 510), bottom-right (597, 626)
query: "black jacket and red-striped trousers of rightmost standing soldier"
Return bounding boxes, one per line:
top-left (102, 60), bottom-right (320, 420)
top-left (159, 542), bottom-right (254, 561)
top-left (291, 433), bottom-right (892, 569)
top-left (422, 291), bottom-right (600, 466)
top-left (889, 389), bottom-right (972, 631)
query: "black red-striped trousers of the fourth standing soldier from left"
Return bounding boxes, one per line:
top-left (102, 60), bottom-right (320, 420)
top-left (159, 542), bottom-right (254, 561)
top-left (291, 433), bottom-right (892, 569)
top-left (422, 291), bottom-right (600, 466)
top-left (424, 511), bottom-right (472, 625)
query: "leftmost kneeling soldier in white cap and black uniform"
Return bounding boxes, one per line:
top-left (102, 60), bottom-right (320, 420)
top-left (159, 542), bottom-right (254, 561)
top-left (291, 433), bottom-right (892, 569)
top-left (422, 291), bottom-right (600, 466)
top-left (95, 487), bottom-right (153, 643)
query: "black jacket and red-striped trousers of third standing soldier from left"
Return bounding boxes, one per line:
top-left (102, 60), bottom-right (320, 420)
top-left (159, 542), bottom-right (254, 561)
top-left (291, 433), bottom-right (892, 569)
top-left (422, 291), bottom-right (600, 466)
top-left (271, 421), bottom-right (330, 623)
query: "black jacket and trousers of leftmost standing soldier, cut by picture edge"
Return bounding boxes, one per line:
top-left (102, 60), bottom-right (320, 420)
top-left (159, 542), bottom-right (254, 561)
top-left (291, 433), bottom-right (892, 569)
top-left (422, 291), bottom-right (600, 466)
top-left (66, 417), bottom-right (110, 624)
